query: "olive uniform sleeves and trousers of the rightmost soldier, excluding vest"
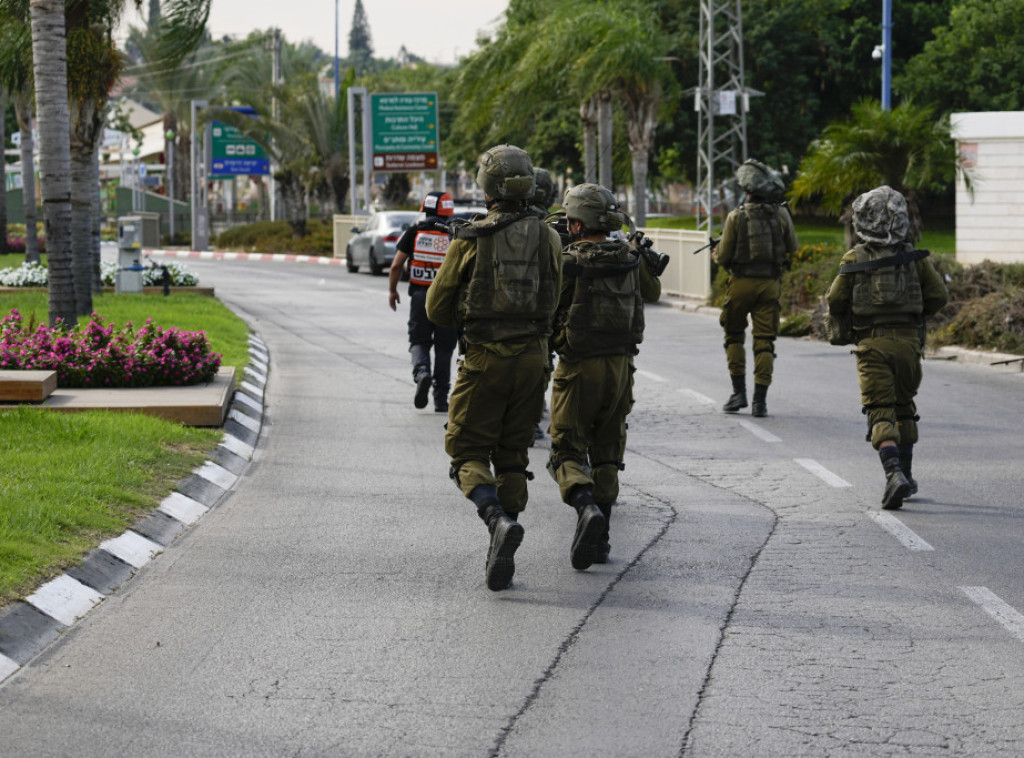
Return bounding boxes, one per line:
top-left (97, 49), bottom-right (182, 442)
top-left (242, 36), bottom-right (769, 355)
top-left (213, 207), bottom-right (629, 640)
top-left (826, 246), bottom-right (949, 450)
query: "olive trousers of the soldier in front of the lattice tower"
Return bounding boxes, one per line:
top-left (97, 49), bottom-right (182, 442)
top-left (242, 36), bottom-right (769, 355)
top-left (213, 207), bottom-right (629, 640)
top-left (719, 277), bottom-right (782, 386)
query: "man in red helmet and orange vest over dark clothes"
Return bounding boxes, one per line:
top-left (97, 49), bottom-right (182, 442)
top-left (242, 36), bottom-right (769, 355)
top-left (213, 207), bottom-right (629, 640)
top-left (388, 192), bottom-right (459, 413)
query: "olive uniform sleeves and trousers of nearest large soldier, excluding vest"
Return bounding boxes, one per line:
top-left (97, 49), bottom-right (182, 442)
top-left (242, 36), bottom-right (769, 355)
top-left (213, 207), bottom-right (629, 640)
top-left (426, 204), bottom-right (561, 513)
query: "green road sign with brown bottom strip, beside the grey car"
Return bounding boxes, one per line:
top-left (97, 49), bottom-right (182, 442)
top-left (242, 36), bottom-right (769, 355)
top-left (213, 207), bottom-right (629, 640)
top-left (370, 92), bottom-right (437, 171)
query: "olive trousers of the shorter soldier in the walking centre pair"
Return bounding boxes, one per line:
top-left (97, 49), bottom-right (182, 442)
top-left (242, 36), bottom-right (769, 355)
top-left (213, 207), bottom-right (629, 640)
top-left (548, 355), bottom-right (636, 505)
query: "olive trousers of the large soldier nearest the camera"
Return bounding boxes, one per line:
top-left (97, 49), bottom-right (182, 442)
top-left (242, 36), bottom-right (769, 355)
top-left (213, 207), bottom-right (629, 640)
top-left (444, 340), bottom-right (548, 513)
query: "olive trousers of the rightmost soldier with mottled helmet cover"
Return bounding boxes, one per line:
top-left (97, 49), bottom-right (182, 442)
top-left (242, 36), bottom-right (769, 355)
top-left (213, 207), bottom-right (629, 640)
top-left (853, 337), bottom-right (923, 450)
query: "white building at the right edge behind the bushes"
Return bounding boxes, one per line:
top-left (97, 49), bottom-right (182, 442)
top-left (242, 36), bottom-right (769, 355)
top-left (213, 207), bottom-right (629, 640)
top-left (950, 111), bottom-right (1024, 263)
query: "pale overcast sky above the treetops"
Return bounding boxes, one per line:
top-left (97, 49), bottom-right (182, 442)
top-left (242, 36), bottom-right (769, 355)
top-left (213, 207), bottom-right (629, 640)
top-left (194, 0), bottom-right (508, 64)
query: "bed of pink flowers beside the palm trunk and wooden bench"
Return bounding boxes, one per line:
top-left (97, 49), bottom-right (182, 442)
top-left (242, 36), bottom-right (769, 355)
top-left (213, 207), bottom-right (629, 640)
top-left (0, 309), bottom-right (221, 387)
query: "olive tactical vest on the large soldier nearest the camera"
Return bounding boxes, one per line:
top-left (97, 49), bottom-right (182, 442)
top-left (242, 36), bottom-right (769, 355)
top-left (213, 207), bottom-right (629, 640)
top-left (455, 211), bottom-right (557, 344)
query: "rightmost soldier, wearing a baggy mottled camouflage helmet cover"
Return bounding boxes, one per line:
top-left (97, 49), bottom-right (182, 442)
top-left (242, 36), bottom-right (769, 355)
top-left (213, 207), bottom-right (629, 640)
top-left (827, 186), bottom-right (948, 510)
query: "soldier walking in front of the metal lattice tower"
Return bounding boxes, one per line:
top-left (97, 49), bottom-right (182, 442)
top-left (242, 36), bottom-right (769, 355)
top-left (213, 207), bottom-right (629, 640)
top-left (715, 159), bottom-right (797, 417)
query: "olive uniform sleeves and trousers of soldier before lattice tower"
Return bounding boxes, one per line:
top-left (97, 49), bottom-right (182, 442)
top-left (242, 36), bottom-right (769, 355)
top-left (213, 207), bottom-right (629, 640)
top-left (715, 202), bottom-right (798, 386)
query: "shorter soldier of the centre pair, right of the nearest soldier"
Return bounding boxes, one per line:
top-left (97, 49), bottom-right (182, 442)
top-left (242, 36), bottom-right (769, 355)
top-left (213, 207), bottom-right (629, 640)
top-left (548, 183), bottom-right (662, 571)
